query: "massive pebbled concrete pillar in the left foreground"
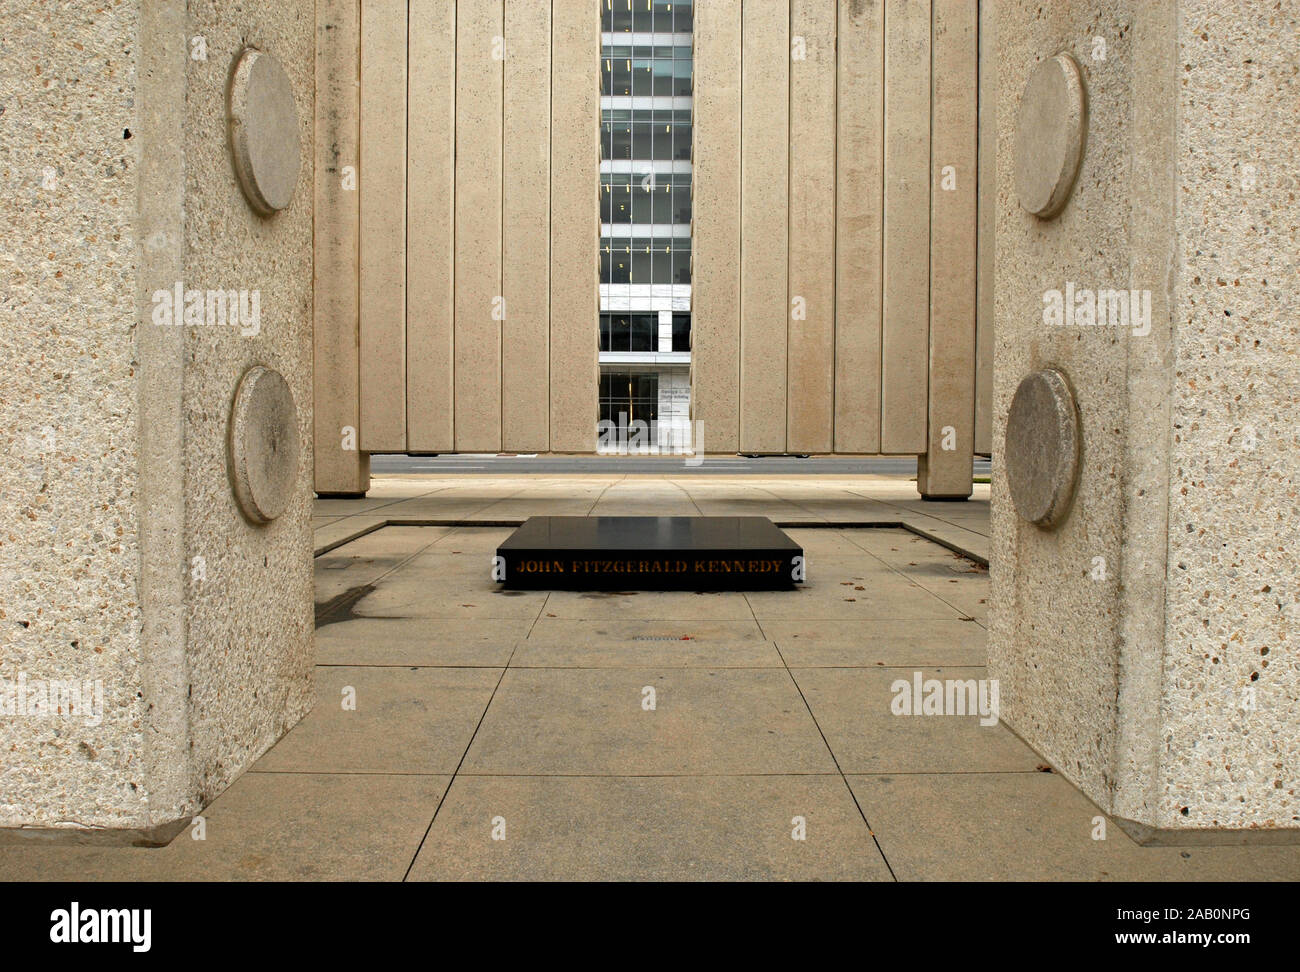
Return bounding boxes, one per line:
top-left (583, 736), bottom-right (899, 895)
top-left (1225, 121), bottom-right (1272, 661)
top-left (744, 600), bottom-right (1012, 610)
top-left (0, 0), bottom-right (316, 842)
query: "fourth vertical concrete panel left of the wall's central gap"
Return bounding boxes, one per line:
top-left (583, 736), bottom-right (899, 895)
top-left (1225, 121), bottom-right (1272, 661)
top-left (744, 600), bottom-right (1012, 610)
top-left (406, 0), bottom-right (456, 452)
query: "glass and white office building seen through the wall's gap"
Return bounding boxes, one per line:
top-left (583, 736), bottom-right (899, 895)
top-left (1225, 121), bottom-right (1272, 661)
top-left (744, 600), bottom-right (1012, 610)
top-left (601, 0), bottom-right (694, 452)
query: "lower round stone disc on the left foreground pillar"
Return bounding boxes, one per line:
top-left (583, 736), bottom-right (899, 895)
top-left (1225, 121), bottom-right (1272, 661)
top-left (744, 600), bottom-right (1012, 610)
top-left (230, 365), bottom-right (298, 524)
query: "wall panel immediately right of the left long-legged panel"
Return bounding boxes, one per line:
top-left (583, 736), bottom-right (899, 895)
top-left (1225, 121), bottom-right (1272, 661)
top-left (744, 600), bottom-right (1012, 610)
top-left (359, 0), bottom-right (407, 452)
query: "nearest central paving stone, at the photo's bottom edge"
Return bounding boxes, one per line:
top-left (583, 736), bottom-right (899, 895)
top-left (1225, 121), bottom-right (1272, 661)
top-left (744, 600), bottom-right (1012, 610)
top-left (411, 774), bottom-right (891, 881)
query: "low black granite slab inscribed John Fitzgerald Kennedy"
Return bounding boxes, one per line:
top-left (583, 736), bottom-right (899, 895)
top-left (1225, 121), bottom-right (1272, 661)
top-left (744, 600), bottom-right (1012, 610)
top-left (493, 516), bottom-right (803, 590)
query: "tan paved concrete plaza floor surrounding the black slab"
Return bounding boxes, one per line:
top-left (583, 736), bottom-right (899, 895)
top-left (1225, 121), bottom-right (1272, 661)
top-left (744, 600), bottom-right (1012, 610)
top-left (0, 476), bottom-right (1300, 881)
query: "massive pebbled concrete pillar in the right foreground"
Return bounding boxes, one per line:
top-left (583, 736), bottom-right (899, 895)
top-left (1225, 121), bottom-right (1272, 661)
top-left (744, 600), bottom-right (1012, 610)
top-left (984, 0), bottom-right (1300, 843)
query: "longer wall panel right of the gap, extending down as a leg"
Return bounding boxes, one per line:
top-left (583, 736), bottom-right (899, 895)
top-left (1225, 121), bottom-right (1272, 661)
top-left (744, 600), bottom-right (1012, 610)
top-left (917, 0), bottom-right (979, 499)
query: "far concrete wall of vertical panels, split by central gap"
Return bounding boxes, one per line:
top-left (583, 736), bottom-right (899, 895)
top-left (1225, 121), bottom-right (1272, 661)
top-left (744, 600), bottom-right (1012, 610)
top-left (315, 0), bottom-right (992, 499)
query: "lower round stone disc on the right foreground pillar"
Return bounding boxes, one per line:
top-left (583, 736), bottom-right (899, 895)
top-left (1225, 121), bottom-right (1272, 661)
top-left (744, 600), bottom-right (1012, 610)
top-left (1006, 369), bottom-right (1079, 528)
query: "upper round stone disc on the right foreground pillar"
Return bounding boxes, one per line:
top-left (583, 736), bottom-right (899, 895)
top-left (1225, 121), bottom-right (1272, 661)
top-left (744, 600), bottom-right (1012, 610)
top-left (1015, 52), bottom-right (1088, 220)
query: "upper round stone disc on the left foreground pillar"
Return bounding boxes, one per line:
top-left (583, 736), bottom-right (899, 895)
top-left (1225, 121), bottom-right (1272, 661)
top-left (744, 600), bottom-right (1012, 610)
top-left (226, 47), bottom-right (302, 216)
